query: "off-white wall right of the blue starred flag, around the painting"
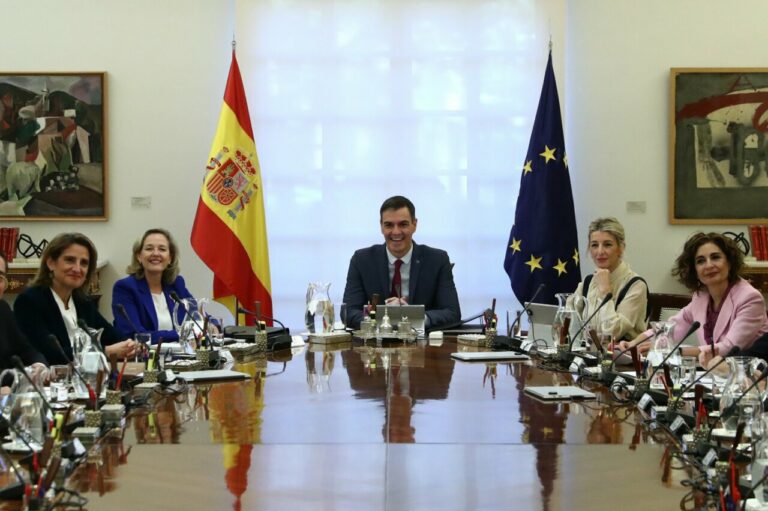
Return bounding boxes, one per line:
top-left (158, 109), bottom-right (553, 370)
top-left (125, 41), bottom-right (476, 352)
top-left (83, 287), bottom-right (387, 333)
top-left (565, 0), bottom-right (768, 292)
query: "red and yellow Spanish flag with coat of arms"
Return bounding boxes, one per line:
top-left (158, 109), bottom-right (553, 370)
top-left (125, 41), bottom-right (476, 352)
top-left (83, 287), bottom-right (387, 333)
top-left (191, 49), bottom-right (272, 323)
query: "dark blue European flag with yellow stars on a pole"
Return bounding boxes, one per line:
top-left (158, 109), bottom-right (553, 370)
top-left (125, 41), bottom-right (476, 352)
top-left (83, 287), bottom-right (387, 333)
top-left (504, 51), bottom-right (581, 303)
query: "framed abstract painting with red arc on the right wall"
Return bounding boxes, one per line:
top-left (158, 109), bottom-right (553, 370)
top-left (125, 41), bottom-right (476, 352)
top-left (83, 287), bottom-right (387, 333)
top-left (669, 68), bottom-right (768, 224)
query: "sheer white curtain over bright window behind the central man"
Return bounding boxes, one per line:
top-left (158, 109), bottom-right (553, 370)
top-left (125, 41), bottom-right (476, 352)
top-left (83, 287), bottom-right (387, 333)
top-left (236, 0), bottom-right (565, 327)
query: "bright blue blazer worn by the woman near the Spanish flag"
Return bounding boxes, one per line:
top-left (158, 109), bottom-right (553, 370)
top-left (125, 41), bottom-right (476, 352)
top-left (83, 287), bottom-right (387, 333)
top-left (112, 275), bottom-right (192, 343)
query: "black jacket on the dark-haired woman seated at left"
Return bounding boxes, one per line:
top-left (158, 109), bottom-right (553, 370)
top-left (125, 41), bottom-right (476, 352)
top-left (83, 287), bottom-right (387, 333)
top-left (13, 286), bottom-right (126, 364)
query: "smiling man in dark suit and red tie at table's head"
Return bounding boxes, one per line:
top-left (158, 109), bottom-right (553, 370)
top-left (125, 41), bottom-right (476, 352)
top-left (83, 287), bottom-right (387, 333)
top-left (344, 195), bottom-right (461, 330)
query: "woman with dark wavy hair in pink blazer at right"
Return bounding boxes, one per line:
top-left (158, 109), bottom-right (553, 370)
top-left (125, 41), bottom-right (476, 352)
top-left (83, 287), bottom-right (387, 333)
top-left (622, 232), bottom-right (768, 365)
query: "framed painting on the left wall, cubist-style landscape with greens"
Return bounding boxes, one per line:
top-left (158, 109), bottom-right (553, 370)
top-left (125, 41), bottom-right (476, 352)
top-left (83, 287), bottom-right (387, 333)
top-left (0, 72), bottom-right (108, 220)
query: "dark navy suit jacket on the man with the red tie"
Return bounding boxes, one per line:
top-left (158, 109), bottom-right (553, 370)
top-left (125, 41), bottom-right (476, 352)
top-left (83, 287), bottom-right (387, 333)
top-left (344, 243), bottom-right (461, 329)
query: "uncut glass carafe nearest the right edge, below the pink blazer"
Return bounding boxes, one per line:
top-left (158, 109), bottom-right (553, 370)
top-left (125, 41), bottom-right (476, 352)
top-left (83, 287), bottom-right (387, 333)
top-left (720, 357), bottom-right (763, 435)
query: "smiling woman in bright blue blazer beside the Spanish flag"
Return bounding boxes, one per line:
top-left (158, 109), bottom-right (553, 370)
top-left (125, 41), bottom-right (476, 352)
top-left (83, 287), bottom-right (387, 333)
top-left (112, 229), bottom-right (192, 343)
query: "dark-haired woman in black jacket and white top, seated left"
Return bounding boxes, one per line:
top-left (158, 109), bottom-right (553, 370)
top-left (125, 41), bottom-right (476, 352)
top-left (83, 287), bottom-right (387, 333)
top-left (13, 233), bottom-right (136, 364)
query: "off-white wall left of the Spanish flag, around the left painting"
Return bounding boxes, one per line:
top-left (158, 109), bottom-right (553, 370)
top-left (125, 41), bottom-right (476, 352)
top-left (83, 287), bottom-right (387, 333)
top-left (2, 0), bottom-right (234, 318)
